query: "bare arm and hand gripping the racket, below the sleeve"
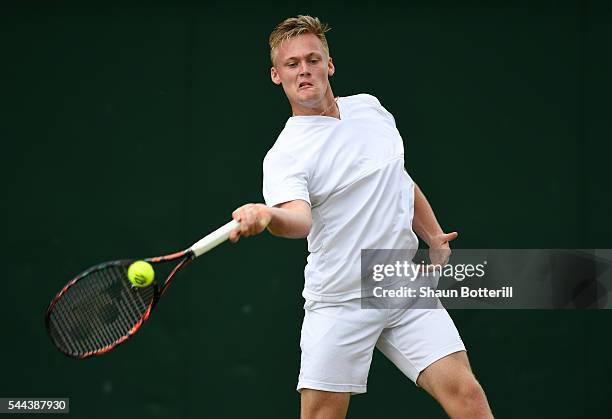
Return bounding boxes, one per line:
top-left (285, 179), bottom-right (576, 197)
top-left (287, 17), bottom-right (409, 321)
top-left (229, 199), bottom-right (312, 243)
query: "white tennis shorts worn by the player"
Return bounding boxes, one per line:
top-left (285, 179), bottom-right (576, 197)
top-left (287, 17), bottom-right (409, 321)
top-left (297, 299), bottom-right (465, 394)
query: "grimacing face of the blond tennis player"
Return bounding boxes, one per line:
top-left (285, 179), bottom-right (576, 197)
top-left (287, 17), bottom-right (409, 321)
top-left (270, 33), bottom-right (335, 108)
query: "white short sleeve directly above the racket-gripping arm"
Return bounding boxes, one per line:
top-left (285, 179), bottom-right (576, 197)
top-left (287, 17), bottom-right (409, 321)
top-left (263, 149), bottom-right (310, 207)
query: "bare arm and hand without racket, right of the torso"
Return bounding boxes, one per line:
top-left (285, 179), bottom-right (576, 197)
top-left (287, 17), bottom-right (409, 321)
top-left (412, 184), bottom-right (459, 265)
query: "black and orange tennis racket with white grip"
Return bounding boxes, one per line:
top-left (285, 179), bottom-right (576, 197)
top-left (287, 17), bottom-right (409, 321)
top-left (45, 220), bottom-right (240, 359)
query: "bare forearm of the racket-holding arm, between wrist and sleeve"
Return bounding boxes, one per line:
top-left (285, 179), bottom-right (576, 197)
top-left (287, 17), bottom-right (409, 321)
top-left (268, 201), bottom-right (312, 239)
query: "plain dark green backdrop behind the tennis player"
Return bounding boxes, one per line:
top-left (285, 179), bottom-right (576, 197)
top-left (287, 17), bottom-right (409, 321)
top-left (0, 1), bottom-right (612, 419)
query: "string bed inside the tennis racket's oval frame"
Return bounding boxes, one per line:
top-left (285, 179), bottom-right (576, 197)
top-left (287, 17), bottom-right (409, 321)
top-left (49, 263), bottom-right (155, 356)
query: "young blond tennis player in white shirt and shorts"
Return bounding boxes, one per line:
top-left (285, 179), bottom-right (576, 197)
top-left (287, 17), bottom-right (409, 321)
top-left (230, 16), bottom-right (492, 419)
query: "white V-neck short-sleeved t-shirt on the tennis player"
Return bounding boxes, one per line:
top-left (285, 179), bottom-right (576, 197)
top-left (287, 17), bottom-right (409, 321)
top-left (263, 94), bottom-right (418, 302)
